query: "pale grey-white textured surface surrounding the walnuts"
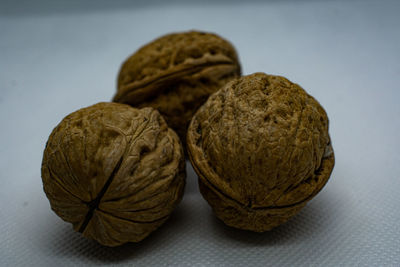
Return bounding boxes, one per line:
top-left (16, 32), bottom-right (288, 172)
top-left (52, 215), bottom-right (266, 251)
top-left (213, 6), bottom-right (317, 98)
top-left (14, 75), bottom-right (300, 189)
top-left (0, 1), bottom-right (400, 266)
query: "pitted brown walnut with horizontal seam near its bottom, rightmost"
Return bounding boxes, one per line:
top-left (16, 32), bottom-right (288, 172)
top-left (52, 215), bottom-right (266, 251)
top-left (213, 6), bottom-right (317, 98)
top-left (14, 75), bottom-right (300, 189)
top-left (187, 73), bottom-right (334, 232)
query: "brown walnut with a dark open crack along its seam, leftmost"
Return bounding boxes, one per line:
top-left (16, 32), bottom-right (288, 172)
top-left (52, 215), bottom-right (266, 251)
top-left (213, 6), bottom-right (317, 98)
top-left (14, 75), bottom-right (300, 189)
top-left (42, 103), bottom-right (186, 246)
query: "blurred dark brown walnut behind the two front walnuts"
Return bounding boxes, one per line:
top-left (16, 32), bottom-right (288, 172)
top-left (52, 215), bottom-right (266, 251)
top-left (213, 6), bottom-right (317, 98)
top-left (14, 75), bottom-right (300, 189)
top-left (114, 31), bottom-right (241, 144)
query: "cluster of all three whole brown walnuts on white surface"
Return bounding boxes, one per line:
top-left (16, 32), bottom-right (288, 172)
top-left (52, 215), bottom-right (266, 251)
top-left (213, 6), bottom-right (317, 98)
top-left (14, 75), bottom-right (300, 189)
top-left (42, 31), bottom-right (334, 246)
